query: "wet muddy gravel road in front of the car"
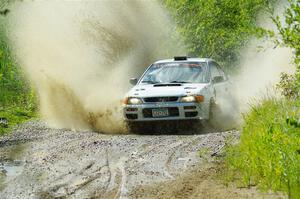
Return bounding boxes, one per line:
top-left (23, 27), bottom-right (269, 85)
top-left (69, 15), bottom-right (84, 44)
top-left (0, 121), bottom-right (285, 199)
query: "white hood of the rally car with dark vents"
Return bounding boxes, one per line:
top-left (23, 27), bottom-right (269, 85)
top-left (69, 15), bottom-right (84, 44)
top-left (127, 84), bottom-right (207, 97)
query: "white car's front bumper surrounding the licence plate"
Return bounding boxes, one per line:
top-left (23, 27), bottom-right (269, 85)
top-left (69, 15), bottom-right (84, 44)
top-left (123, 102), bottom-right (208, 121)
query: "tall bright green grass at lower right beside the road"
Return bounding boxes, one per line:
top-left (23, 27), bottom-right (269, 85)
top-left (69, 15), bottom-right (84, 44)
top-left (227, 99), bottom-right (300, 198)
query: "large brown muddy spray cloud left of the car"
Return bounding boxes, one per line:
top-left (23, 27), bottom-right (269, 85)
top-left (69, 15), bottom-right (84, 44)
top-left (9, 0), bottom-right (185, 133)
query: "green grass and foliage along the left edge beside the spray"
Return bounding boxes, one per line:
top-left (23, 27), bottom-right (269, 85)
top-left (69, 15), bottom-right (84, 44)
top-left (0, 16), bottom-right (36, 134)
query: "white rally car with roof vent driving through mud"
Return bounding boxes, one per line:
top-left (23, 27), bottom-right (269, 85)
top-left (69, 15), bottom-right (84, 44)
top-left (123, 57), bottom-right (229, 127)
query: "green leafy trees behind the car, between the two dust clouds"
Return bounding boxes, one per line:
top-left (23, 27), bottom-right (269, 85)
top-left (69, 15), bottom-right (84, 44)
top-left (164, 0), bottom-right (275, 69)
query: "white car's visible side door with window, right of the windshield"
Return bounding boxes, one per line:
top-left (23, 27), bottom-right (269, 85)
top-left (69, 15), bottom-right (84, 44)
top-left (209, 61), bottom-right (228, 102)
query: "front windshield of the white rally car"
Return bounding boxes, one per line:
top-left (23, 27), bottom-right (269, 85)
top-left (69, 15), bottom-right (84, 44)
top-left (141, 62), bottom-right (207, 84)
